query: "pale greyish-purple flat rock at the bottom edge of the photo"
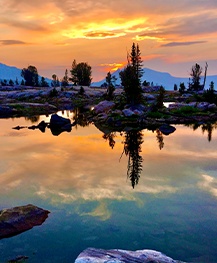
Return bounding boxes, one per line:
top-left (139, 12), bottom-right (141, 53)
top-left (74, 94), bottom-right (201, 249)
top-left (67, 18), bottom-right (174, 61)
top-left (75, 248), bottom-right (183, 263)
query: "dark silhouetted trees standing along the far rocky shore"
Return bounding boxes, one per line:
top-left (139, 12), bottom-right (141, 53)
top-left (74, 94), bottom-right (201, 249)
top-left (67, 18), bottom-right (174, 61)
top-left (0, 43), bottom-right (214, 98)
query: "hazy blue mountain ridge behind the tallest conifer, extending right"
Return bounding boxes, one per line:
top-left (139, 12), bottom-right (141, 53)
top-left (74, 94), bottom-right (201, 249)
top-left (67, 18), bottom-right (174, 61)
top-left (92, 68), bottom-right (217, 90)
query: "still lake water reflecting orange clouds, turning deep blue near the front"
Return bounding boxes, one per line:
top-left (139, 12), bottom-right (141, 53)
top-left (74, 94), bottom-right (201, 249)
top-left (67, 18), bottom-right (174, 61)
top-left (0, 112), bottom-right (217, 263)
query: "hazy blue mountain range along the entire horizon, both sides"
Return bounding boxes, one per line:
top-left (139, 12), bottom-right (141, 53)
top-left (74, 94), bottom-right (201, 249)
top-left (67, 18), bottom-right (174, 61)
top-left (0, 63), bottom-right (217, 90)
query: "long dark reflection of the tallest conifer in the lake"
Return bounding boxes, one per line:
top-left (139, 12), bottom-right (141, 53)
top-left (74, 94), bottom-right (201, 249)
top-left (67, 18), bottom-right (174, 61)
top-left (124, 131), bottom-right (143, 188)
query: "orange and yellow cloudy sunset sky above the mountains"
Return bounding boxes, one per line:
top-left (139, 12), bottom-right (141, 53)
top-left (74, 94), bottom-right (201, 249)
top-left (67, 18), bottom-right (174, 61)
top-left (0, 0), bottom-right (217, 81)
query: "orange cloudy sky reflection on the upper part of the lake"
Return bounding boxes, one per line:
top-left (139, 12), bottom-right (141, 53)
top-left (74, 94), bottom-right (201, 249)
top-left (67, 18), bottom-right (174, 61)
top-left (0, 117), bottom-right (217, 214)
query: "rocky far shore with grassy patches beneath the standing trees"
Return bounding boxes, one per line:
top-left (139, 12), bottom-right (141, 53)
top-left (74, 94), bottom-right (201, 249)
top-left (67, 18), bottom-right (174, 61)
top-left (0, 86), bottom-right (217, 130)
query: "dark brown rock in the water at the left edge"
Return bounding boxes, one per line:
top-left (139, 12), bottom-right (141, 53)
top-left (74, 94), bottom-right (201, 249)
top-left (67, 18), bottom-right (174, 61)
top-left (0, 204), bottom-right (50, 239)
